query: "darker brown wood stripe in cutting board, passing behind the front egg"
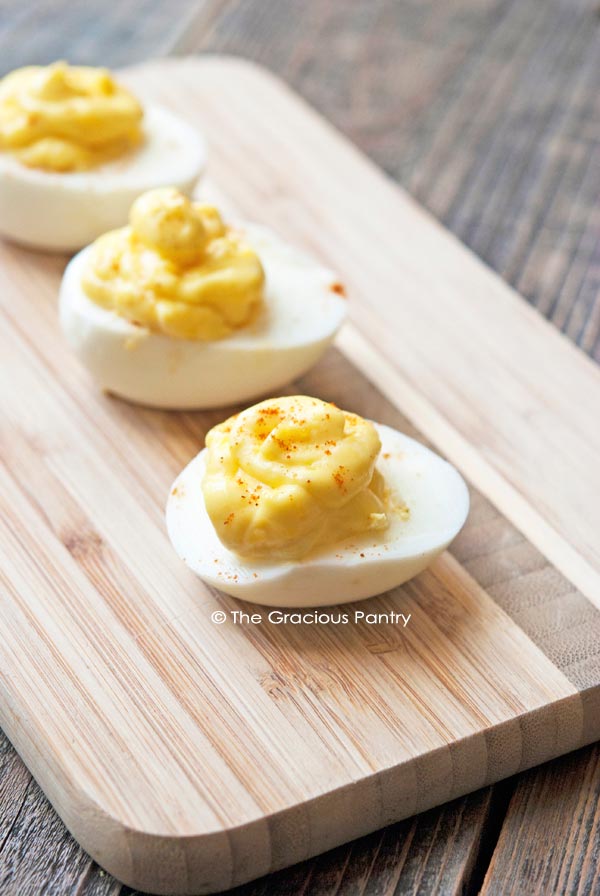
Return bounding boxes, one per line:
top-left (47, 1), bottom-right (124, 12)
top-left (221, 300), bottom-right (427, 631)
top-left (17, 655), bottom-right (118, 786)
top-left (300, 352), bottom-right (600, 720)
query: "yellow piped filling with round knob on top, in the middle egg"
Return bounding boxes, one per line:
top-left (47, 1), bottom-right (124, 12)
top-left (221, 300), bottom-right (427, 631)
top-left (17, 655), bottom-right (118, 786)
top-left (82, 187), bottom-right (265, 340)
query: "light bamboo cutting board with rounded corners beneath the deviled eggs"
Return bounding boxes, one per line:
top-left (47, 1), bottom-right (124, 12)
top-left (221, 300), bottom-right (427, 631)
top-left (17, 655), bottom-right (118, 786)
top-left (0, 57), bottom-right (600, 893)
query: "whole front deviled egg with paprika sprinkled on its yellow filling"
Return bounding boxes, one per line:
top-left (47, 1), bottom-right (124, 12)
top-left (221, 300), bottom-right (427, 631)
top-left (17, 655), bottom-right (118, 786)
top-left (167, 396), bottom-right (469, 607)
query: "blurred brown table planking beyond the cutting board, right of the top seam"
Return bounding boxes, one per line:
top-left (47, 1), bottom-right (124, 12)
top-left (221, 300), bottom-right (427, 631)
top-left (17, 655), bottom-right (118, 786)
top-left (200, 0), bottom-right (600, 359)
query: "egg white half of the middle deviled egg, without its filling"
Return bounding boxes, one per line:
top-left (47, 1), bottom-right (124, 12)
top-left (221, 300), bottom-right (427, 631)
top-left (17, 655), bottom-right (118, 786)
top-left (60, 225), bottom-right (346, 409)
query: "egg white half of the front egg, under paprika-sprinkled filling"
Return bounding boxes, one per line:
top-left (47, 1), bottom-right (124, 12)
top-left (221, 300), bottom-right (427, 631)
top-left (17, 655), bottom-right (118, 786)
top-left (166, 424), bottom-right (469, 607)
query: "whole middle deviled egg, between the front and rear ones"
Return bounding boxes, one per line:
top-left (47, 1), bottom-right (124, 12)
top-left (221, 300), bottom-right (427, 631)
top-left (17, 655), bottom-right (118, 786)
top-left (60, 188), bottom-right (346, 408)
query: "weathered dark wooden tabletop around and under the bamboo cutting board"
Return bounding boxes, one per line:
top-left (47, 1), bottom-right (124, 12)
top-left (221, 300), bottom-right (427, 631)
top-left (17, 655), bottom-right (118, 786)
top-left (0, 0), bottom-right (600, 896)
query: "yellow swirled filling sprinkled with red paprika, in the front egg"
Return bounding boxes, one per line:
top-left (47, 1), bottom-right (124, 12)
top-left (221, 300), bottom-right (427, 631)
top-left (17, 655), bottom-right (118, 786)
top-left (202, 396), bottom-right (389, 560)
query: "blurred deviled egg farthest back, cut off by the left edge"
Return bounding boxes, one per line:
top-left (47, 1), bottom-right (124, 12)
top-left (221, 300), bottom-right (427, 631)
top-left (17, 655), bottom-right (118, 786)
top-left (0, 62), bottom-right (205, 251)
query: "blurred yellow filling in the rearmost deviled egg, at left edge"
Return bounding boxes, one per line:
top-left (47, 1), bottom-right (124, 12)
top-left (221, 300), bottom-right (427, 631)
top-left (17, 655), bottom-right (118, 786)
top-left (0, 62), bottom-right (143, 173)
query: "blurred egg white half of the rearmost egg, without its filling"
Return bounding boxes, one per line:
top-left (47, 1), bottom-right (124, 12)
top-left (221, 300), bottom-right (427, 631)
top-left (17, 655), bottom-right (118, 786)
top-left (0, 106), bottom-right (206, 252)
